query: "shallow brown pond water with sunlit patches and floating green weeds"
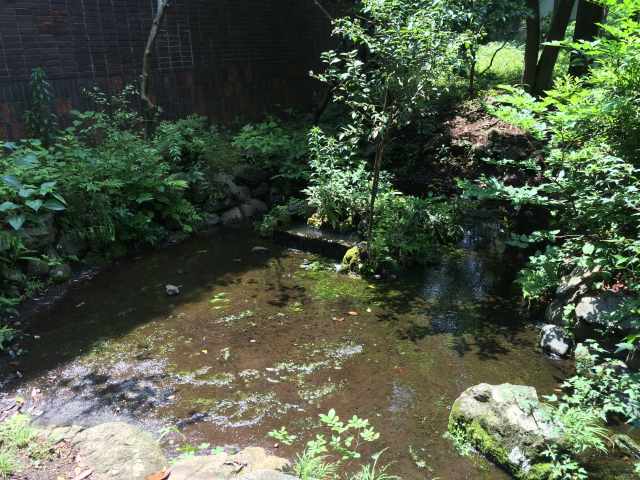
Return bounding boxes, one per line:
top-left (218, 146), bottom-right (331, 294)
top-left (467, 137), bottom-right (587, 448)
top-left (1, 229), bottom-right (567, 479)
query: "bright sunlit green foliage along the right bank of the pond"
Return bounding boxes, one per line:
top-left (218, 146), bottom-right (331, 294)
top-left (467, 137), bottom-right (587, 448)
top-left (463, 2), bottom-right (640, 330)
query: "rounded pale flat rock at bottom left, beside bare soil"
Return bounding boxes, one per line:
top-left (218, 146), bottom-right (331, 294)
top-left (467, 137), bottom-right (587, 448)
top-left (71, 422), bottom-right (168, 480)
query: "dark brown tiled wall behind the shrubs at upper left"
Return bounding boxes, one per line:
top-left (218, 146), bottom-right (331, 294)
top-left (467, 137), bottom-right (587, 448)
top-left (0, 0), bottom-right (330, 138)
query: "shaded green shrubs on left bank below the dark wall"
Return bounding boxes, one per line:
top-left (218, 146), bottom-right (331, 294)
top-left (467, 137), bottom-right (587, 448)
top-left (0, 87), bottom-right (239, 318)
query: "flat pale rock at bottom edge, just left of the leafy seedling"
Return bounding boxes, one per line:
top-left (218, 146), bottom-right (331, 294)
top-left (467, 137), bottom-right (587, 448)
top-left (171, 447), bottom-right (295, 480)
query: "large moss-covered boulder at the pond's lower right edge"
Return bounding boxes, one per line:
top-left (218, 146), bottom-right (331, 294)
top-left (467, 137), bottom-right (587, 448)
top-left (449, 383), bottom-right (560, 480)
